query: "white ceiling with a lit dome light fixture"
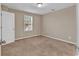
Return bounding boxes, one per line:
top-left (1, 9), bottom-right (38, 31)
top-left (3, 3), bottom-right (74, 15)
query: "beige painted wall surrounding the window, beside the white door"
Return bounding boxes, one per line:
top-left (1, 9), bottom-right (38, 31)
top-left (2, 6), bottom-right (41, 39)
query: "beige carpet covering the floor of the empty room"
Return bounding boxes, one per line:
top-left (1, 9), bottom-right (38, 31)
top-left (2, 36), bottom-right (75, 56)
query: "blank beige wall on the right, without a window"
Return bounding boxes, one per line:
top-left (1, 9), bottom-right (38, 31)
top-left (41, 6), bottom-right (76, 43)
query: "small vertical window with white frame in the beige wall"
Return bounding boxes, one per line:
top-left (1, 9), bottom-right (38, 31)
top-left (24, 15), bottom-right (33, 31)
